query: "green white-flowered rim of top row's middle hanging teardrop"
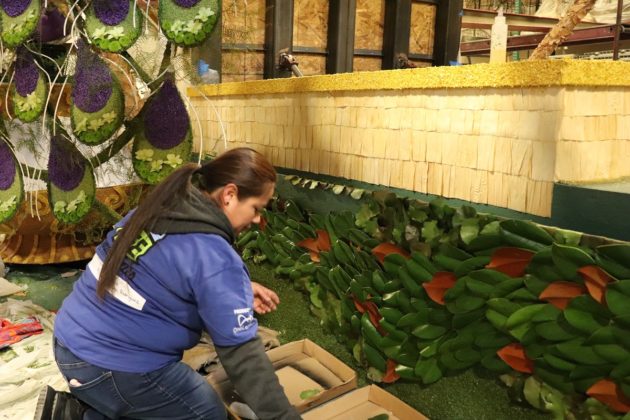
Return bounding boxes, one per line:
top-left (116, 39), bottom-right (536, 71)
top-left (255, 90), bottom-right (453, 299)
top-left (85, 1), bottom-right (143, 53)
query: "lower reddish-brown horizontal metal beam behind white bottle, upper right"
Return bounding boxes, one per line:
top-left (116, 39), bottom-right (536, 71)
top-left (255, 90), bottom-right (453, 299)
top-left (462, 25), bottom-right (630, 55)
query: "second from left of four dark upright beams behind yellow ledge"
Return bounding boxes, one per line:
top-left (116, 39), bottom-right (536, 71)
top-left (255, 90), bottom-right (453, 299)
top-left (326, 0), bottom-right (357, 73)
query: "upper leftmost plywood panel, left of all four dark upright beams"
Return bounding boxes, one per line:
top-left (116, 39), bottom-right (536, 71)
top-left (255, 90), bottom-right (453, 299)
top-left (221, 0), bottom-right (265, 44)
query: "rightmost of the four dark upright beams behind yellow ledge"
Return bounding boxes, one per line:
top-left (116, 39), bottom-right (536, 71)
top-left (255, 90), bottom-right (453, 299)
top-left (433, 0), bottom-right (464, 66)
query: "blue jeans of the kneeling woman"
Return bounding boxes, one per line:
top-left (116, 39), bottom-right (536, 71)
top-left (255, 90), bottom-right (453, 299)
top-left (54, 338), bottom-right (227, 420)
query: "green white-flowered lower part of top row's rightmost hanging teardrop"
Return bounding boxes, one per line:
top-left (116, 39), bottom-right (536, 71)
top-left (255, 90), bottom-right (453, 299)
top-left (159, 0), bottom-right (220, 47)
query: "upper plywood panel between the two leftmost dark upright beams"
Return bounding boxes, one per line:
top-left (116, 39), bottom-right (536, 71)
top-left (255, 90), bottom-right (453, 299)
top-left (293, 0), bottom-right (329, 48)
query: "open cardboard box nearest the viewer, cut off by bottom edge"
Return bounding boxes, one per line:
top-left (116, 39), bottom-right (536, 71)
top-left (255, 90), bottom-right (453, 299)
top-left (302, 385), bottom-right (427, 420)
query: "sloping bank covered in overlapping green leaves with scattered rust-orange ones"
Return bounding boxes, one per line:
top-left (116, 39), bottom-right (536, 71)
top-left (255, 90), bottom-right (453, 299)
top-left (239, 189), bottom-right (630, 418)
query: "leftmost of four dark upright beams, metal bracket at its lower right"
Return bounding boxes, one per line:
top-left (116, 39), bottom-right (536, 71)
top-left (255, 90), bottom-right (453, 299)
top-left (264, 0), bottom-right (293, 79)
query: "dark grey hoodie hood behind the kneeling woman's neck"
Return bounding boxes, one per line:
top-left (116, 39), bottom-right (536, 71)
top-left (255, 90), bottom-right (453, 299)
top-left (151, 185), bottom-right (236, 244)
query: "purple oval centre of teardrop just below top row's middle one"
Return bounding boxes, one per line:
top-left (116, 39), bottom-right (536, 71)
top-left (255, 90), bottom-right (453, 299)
top-left (72, 41), bottom-right (113, 112)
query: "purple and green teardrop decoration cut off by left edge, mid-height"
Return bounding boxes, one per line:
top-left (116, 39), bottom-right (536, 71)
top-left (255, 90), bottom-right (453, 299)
top-left (0, 139), bottom-right (24, 223)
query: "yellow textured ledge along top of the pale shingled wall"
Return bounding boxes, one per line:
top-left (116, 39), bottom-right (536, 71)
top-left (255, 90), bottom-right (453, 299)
top-left (188, 60), bottom-right (630, 97)
